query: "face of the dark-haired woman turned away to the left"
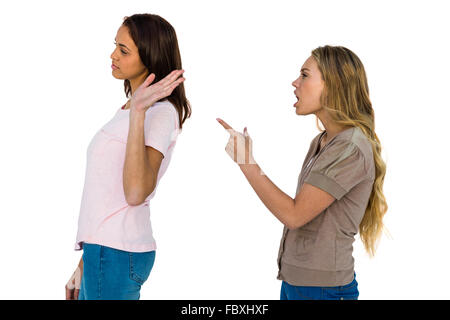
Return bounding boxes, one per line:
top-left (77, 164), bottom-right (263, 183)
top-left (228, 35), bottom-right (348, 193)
top-left (110, 25), bottom-right (147, 81)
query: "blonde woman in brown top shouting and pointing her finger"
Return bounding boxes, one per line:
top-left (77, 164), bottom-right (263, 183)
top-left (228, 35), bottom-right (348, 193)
top-left (217, 46), bottom-right (387, 300)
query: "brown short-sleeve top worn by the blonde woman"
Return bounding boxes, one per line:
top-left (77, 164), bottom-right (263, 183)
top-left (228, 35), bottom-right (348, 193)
top-left (277, 127), bottom-right (375, 286)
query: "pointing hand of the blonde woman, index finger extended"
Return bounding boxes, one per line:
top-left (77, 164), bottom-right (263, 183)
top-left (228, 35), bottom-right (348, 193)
top-left (217, 118), bottom-right (256, 164)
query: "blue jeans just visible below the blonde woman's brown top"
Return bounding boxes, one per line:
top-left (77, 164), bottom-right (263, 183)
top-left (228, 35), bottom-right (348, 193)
top-left (280, 274), bottom-right (359, 300)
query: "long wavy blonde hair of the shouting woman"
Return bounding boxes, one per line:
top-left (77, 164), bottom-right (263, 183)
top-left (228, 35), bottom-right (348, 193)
top-left (311, 45), bottom-right (388, 257)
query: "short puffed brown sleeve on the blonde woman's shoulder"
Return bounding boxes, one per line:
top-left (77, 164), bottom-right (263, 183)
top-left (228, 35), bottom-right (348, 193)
top-left (304, 140), bottom-right (367, 200)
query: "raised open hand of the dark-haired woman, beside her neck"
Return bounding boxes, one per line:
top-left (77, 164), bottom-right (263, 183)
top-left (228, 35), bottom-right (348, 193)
top-left (130, 70), bottom-right (185, 112)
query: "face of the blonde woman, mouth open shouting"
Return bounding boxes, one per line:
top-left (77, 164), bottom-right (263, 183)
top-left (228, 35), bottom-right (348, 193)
top-left (292, 56), bottom-right (324, 115)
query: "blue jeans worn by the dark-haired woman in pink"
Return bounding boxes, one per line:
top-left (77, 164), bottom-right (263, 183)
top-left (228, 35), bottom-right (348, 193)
top-left (78, 242), bottom-right (155, 300)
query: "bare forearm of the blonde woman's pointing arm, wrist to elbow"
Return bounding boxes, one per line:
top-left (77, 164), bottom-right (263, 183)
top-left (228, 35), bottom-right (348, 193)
top-left (239, 164), bottom-right (294, 228)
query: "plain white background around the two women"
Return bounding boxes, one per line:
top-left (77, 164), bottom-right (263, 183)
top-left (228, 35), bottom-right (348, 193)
top-left (0, 0), bottom-right (450, 299)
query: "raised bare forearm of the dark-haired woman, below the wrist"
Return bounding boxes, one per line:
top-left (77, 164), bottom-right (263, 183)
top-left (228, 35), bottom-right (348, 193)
top-left (123, 112), bottom-right (154, 204)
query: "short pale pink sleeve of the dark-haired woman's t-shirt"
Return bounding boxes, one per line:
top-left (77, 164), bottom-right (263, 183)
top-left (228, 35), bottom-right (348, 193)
top-left (144, 103), bottom-right (178, 157)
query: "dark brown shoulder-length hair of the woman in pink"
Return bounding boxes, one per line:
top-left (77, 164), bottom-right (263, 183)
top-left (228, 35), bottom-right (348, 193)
top-left (122, 13), bottom-right (192, 129)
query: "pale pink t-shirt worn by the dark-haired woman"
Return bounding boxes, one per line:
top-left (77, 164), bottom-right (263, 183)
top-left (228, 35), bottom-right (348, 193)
top-left (75, 100), bottom-right (181, 252)
